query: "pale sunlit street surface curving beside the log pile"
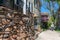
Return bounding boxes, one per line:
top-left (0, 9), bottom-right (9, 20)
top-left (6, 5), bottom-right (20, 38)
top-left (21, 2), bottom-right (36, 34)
top-left (36, 30), bottom-right (60, 40)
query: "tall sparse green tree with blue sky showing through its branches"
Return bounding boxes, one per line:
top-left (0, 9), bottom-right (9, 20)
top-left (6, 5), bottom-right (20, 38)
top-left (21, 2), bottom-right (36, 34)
top-left (45, 0), bottom-right (59, 24)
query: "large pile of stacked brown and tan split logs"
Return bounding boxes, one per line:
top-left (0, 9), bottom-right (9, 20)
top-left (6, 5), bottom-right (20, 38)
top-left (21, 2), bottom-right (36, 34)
top-left (0, 7), bottom-right (34, 40)
